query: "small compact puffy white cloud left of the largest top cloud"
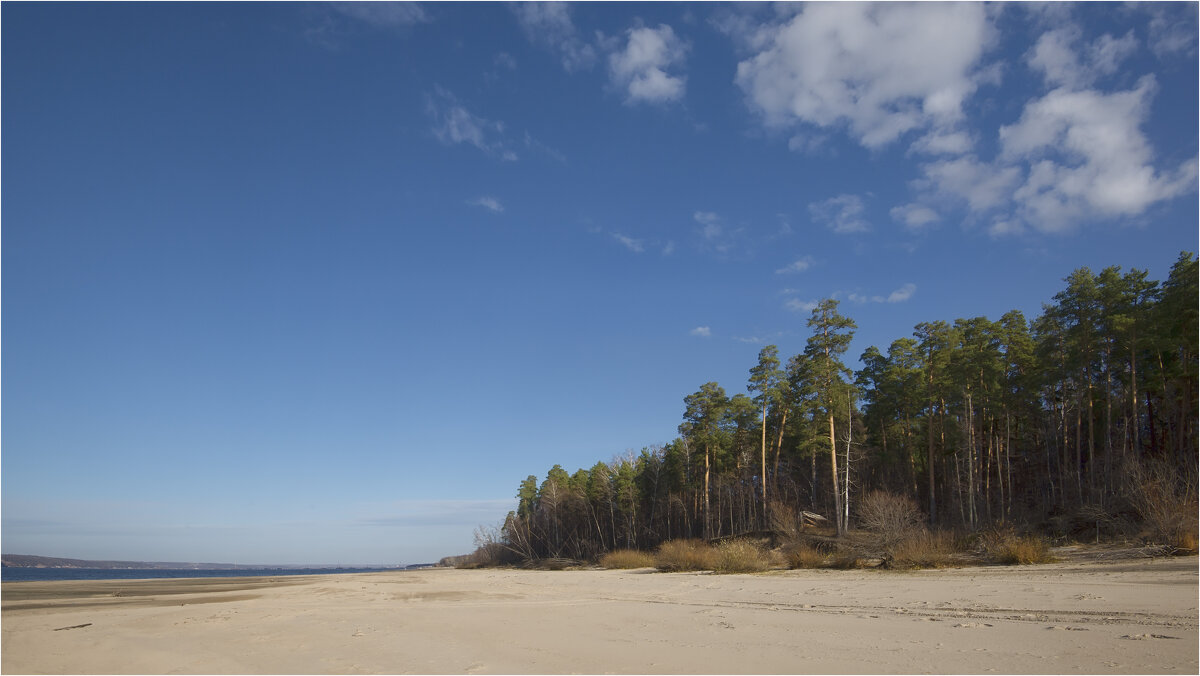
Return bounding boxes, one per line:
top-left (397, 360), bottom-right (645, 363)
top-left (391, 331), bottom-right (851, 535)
top-left (608, 24), bottom-right (688, 104)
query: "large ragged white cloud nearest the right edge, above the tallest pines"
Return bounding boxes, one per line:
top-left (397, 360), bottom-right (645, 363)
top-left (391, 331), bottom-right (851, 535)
top-left (892, 64), bottom-right (1196, 237)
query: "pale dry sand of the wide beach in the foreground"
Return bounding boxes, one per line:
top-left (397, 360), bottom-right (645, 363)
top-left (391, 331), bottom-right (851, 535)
top-left (0, 557), bottom-right (1200, 674)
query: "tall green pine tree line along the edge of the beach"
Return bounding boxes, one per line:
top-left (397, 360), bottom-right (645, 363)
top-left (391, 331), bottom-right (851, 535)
top-left (493, 252), bottom-right (1200, 560)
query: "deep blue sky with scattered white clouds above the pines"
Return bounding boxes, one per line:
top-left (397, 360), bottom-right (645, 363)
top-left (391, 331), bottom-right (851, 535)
top-left (0, 2), bottom-right (1200, 564)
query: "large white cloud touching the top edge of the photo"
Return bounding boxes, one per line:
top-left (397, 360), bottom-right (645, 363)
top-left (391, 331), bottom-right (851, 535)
top-left (731, 2), bottom-right (992, 148)
